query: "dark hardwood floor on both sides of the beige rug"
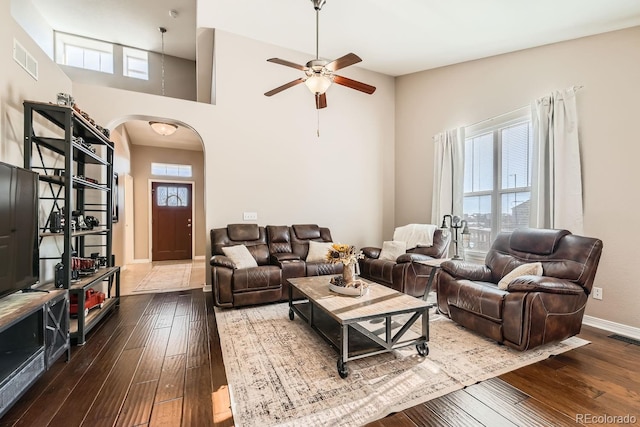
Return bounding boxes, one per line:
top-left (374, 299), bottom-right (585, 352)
top-left (0, 290), bottom-right (640, 427)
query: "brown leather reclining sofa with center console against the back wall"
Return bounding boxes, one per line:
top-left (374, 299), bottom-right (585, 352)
top-left (209, 224), bottom-right (342, 307)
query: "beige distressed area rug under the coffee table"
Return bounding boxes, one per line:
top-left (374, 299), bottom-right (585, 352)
top-left (216, 303), bottom-right (588, 427)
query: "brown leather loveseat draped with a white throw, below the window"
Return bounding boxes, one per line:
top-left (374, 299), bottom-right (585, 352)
top-left (359, 229), bottom-right (451, 298)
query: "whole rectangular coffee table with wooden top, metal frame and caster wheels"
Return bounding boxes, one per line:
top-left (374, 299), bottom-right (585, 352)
top-left (288, 276), bottom-right (429, 378)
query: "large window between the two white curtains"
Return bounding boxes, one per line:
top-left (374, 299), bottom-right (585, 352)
top-left (463, 108), bottom-right (533, 255)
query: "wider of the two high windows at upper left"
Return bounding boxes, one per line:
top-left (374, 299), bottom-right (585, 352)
top-left (56, 33), bottom-right (113, 74)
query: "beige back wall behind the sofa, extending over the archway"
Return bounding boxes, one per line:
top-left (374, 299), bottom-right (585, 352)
top-left (73, 31), bottom-right (394, 253)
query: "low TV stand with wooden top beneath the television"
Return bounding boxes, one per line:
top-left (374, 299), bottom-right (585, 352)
top-left (0, 289), bottom-right (71, 417)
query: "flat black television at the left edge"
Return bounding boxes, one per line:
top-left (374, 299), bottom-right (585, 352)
top-left (0, 162), bottom-right (40, 297)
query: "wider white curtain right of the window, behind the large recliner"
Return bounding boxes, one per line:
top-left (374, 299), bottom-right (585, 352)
top-left (530, 87), bottom-right (583, 234)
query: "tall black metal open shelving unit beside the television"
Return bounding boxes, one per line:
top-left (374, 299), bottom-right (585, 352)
top-left (24, 101), bottom-right (120, 345)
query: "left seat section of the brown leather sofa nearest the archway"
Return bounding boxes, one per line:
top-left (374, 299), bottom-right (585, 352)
top-left (210, 224), bottom-right (282, 307)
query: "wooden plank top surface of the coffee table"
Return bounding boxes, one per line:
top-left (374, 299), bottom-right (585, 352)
top-left (288, 276), bottom-right (427, 324)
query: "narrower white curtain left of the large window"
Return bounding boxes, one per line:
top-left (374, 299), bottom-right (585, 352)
top-left (431, 128), bottom-right (464, 225)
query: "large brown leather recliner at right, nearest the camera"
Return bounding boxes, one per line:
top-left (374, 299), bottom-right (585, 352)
top-left (437, 229), bottom-right (602, 350)
